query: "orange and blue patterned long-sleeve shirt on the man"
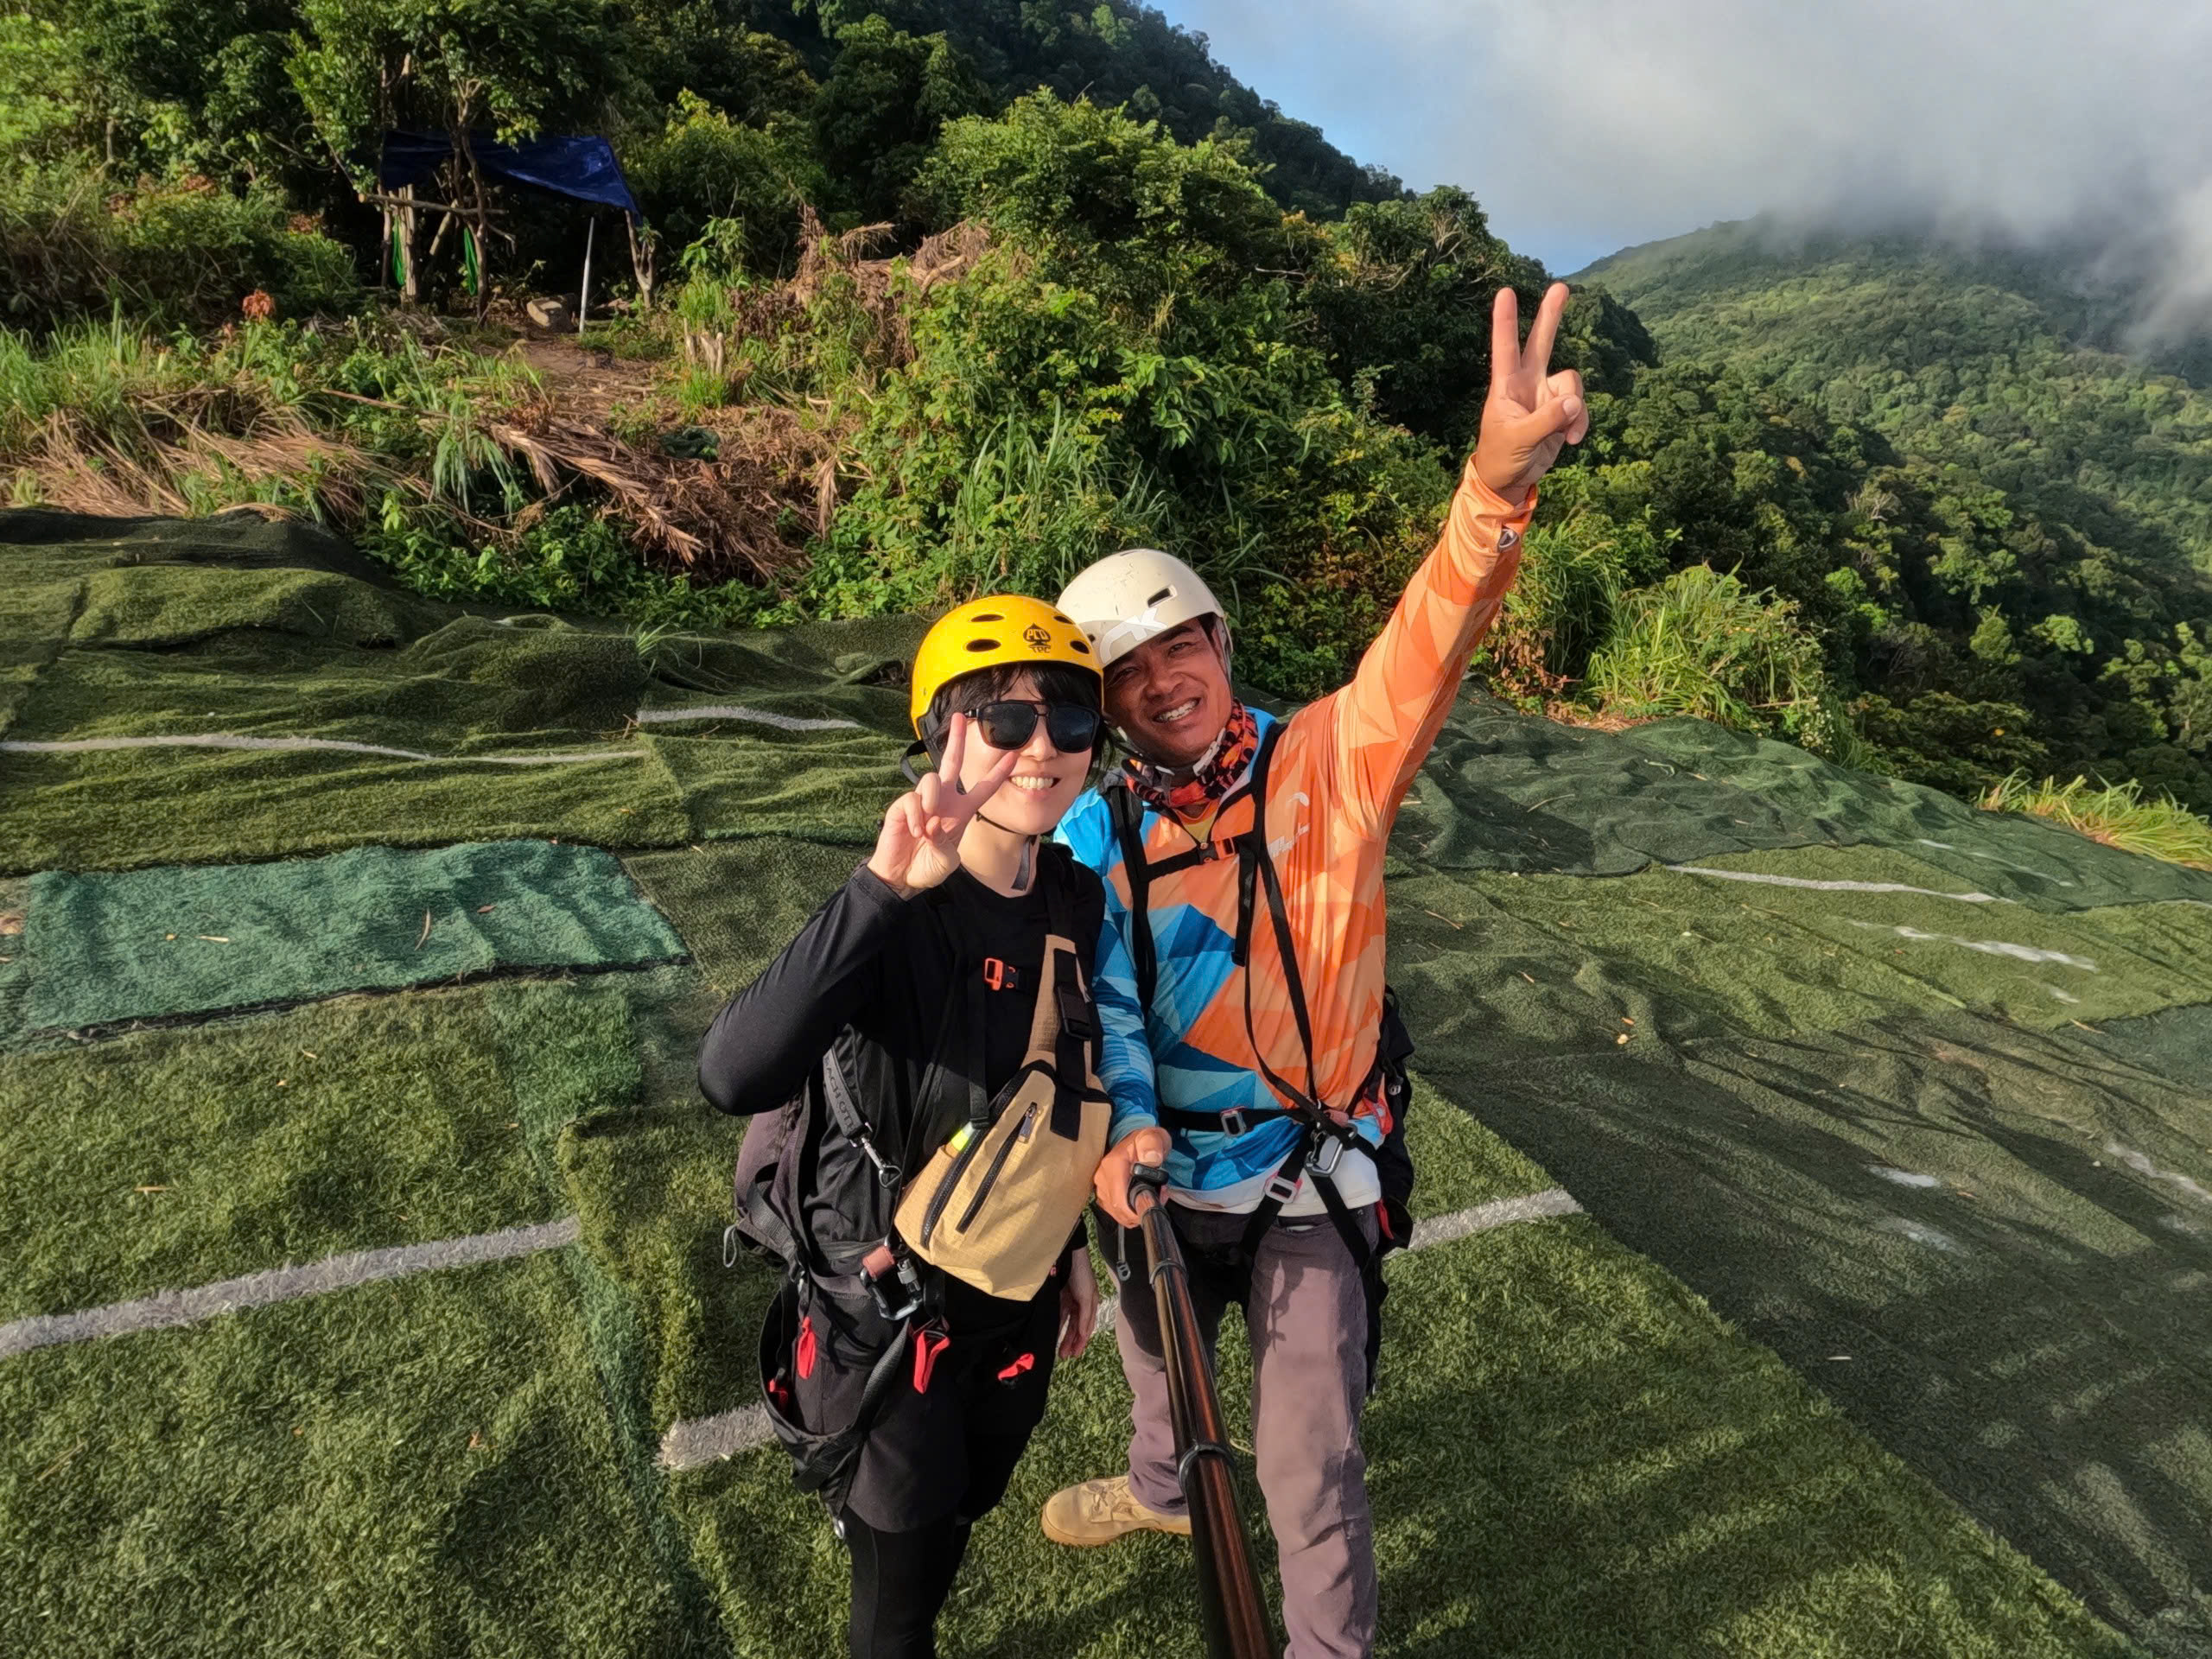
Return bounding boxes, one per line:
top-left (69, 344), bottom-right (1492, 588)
top-left (1059, 462), bottom-right (1535, 1214)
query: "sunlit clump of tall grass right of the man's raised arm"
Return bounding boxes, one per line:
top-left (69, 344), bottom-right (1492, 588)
top-left (1588, 564), bottom-right (1865, 766)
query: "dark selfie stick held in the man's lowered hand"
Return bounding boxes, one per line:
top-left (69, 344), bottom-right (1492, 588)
top-left (1128, 1164), bottom-right (1276, 1659)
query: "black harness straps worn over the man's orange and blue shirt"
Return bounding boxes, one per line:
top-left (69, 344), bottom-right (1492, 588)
top-left (1103, 721), bottom-right (1414, 1389)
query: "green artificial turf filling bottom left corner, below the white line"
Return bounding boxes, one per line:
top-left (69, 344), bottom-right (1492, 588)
top-left (0, 1252), bottom-right (698, 1659)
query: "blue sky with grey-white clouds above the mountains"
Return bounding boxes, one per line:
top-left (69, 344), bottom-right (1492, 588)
top-left (1154, 0), bottom-right (2212, 291)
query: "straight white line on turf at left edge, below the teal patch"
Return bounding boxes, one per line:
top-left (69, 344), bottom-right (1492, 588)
top-left (0, 1214), bottom-right (582, 1360)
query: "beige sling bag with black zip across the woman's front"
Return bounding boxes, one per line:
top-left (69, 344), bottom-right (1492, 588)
top-left (898, 933), bottom-right (1113, 1300)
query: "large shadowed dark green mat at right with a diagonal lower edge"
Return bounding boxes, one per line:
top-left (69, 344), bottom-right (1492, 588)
top-left (1415, 1007), bottom-right (2212, 1659)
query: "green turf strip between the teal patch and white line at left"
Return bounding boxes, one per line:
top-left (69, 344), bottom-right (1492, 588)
top-left (0, 987), bottom-right (575, 1327)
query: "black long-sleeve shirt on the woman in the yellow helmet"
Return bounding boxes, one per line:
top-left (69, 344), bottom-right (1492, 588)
top-left (699, 858), bottom-right (1106, 1312)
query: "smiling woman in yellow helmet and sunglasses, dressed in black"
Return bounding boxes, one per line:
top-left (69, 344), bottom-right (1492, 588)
top-left (699, 595), bottom-right (1109, 1659)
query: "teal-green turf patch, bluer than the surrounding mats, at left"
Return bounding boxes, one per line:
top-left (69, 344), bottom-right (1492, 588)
top-left (15, 841), bottom-right (683, 1031)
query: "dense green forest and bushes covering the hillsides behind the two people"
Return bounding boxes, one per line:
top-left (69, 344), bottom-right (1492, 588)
top-left (0, 0), bottom-right (2212, 831)
